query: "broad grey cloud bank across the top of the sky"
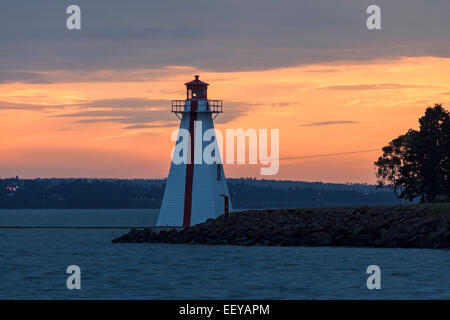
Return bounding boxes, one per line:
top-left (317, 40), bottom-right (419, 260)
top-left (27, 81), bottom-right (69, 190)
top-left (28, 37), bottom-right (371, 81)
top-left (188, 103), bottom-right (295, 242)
top-left (0, 0), bottom-right (450, 78)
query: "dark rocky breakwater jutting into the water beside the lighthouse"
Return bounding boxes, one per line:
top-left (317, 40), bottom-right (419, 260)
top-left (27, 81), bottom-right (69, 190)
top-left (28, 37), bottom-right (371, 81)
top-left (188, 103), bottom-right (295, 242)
top-left (113, 206), bottom-right (450, 249)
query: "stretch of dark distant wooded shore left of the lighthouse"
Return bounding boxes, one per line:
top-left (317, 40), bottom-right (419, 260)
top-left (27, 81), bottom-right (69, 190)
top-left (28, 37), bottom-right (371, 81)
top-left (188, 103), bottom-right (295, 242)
top-left (0, 179), bottom-right (164, 209)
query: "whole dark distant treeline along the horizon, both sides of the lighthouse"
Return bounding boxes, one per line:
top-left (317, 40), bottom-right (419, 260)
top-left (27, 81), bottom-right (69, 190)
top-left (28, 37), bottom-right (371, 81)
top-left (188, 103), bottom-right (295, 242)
top-left (0, 177), bottom-right (397, 209)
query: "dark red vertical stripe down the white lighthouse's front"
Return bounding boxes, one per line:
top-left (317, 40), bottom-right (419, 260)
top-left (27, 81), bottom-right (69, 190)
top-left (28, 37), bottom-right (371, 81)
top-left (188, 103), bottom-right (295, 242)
top-left (183, 101), bottom-right (198, 227)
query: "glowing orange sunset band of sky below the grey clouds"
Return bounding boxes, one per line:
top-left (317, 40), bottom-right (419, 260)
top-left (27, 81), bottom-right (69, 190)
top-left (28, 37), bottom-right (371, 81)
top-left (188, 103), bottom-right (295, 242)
top-left (0, 57), bottom-right (450, 183)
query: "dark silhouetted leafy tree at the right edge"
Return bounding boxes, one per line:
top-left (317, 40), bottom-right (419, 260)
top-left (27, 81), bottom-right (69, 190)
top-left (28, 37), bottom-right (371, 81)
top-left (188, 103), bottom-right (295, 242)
top-left (375, 104), bottom-right (450, 202)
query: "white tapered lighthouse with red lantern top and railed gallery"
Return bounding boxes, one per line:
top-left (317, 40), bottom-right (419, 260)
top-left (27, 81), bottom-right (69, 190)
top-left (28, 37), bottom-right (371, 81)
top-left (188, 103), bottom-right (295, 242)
top-left (157, 75), bottom-right (231, 227)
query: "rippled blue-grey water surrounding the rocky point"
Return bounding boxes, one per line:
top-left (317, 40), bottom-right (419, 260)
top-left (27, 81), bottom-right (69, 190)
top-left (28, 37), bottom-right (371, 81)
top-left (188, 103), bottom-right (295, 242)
top-left (0, 210), bottom-right (450, 299)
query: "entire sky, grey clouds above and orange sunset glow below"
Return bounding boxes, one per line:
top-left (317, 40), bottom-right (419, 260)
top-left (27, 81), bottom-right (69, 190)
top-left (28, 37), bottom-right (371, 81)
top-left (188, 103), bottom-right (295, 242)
top-left (0, 0), bottom-right (450, 183)
